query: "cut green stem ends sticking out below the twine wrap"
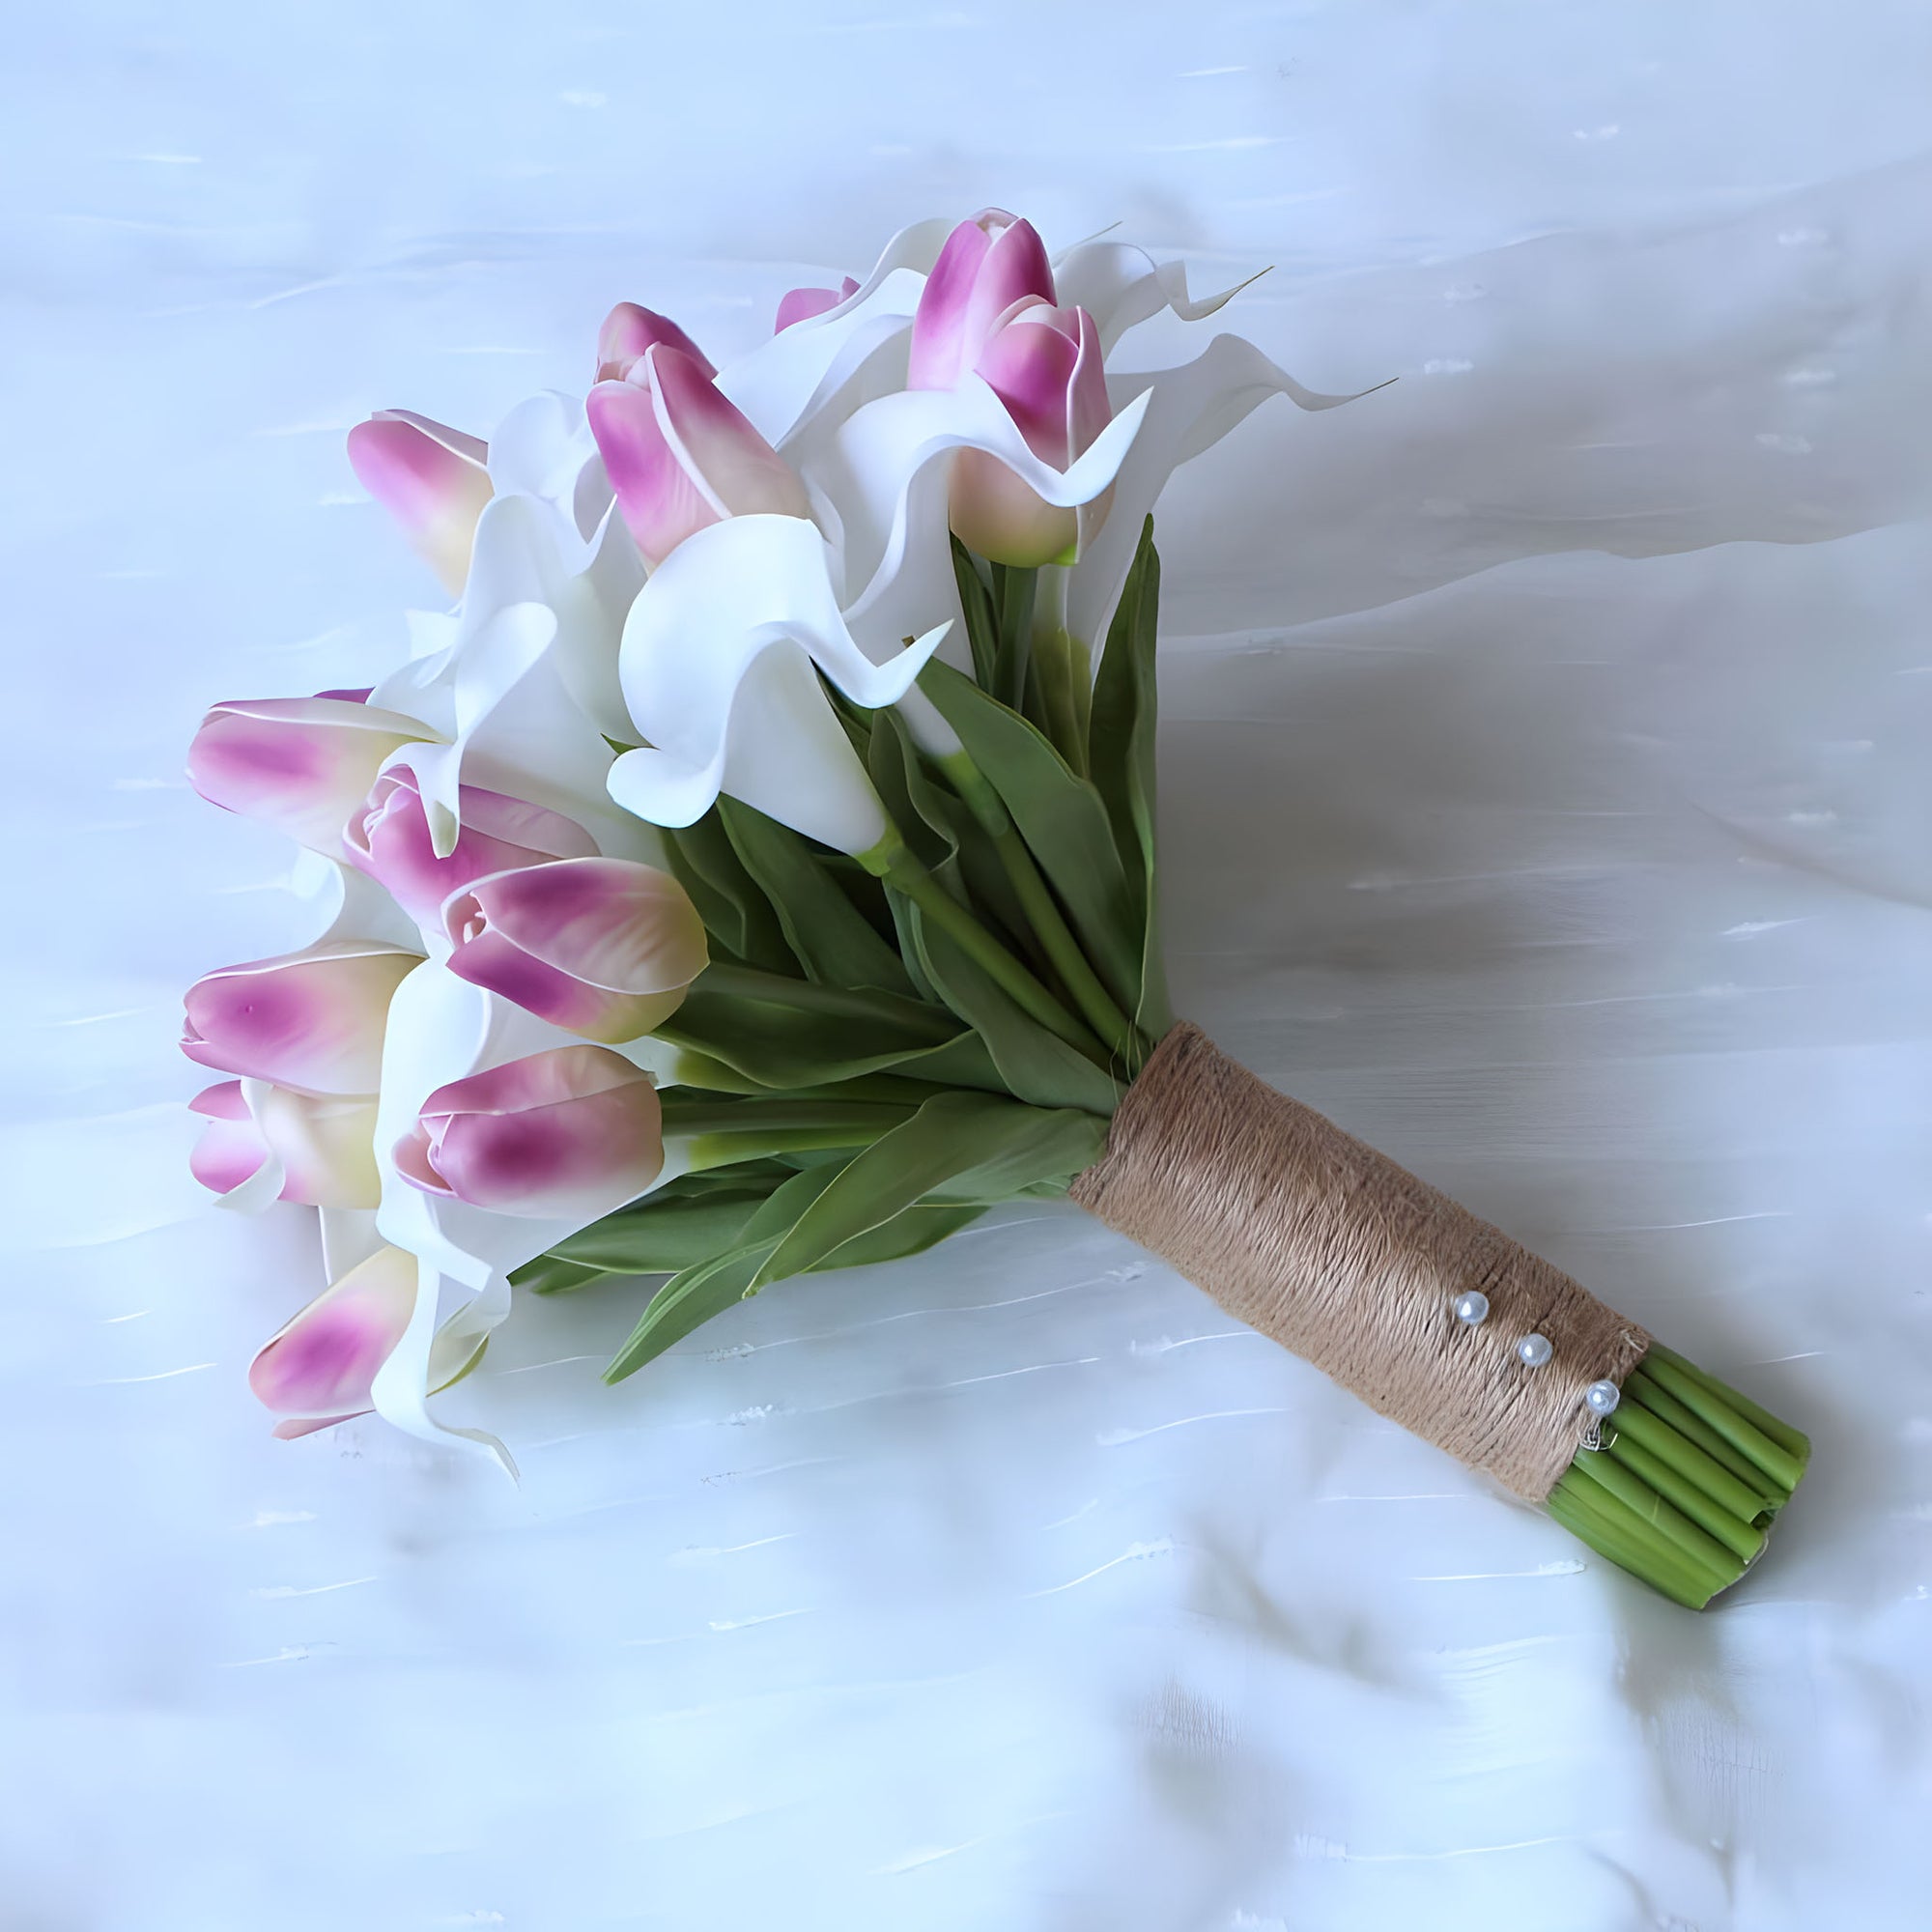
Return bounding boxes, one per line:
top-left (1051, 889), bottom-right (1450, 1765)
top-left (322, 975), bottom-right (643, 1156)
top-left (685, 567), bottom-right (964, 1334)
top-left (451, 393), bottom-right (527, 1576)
top-left (1548, 1343), bottom-right (1810, 1609)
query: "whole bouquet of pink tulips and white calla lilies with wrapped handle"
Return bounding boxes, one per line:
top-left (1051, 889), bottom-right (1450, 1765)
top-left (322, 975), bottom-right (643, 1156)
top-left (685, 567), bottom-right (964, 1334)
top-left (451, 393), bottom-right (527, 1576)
top-left (184, 209), bottom-right (1808, 1607)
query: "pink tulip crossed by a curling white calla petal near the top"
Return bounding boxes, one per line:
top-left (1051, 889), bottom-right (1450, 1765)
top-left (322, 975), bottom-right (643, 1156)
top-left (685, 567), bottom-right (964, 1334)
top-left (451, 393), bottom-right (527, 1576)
top-left (952, 301), bottom-right (1111, 566)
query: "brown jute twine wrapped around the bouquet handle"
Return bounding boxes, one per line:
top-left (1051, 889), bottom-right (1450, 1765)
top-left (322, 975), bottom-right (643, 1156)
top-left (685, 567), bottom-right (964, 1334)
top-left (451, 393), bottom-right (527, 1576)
top-left (1072, 1022), bottom-right (1650, 1503)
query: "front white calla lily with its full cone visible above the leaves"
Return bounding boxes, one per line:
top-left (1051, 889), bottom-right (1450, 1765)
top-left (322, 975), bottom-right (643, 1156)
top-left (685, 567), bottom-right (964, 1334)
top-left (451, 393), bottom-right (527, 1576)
top-left (611, 516), bottom-right (949, 852)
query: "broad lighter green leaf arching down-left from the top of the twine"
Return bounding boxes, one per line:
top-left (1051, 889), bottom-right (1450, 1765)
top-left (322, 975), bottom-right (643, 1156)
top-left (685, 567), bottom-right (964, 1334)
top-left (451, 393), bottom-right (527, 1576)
top-left (755, 1094), bottom-right (1107, 1285)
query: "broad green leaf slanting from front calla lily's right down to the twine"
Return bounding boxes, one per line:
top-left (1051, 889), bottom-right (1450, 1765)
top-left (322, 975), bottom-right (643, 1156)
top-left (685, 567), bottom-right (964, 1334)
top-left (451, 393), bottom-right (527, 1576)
top-left (920, 661), bottom-right (1146, 1012)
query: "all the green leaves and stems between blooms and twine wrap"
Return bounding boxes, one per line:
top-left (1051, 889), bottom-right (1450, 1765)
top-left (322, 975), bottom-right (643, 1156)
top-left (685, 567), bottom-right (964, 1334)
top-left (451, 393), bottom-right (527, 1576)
top-left (514, 522), bottom-right (1167, 1381)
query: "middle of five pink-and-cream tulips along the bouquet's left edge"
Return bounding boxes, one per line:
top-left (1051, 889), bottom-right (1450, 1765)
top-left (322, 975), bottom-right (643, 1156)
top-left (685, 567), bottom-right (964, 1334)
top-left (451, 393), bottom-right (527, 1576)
top-left (182, 939), bottom-right (421, 1095)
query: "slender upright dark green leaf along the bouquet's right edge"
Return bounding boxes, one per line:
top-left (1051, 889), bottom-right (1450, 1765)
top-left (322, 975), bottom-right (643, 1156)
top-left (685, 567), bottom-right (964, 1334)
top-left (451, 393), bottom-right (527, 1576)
top-left (1088, 516), bottom-right (1173, 1037)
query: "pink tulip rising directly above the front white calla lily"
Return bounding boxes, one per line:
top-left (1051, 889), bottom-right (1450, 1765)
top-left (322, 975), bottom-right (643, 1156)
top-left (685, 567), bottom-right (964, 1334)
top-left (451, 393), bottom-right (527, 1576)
top-left (585, 342), bottom-right (811, 568)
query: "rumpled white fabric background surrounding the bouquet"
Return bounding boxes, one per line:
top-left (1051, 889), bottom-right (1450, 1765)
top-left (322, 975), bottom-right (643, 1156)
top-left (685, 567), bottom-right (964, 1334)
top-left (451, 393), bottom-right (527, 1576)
top-left (0, 0), bottom-right (1932, 1932)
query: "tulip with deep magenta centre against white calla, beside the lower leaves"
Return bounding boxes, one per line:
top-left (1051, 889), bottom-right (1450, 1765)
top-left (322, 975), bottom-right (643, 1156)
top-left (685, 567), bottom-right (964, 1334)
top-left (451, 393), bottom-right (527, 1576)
top-left (396, 1047), bottom-right (665, 1223)
